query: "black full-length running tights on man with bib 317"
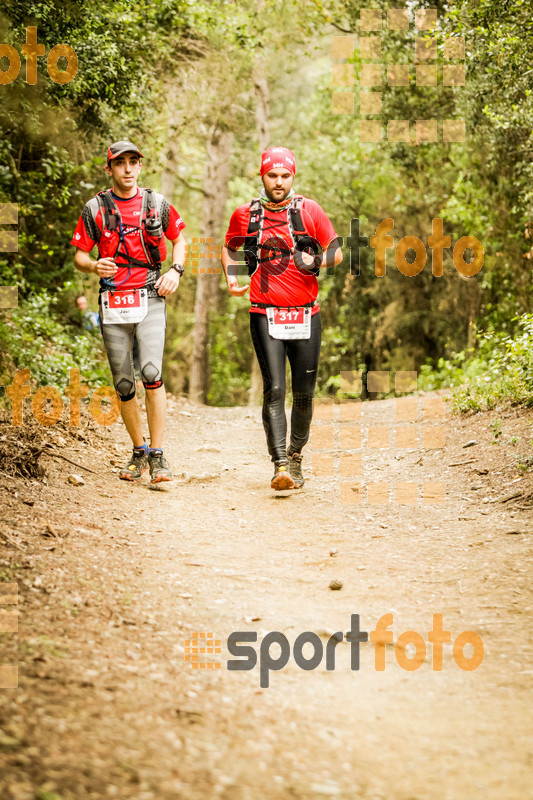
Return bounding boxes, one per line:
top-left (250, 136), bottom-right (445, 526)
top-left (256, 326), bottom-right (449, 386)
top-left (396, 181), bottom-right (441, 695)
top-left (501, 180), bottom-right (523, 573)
top-left (250, 312), bottom-right (321, 461)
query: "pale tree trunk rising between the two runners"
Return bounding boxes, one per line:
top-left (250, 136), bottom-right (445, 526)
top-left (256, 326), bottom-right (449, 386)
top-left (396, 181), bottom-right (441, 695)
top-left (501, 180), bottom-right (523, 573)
top-left (189, 125), bottom-right (233, 403)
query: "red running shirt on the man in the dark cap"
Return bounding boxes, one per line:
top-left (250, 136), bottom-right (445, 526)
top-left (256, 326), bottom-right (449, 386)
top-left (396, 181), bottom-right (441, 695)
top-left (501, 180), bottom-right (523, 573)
top-left (71, 189), bottom-right (185, 289)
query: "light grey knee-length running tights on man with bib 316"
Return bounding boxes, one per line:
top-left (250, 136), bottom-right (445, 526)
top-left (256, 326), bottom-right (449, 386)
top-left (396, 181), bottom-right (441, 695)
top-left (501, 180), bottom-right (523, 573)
top-left (100, 297), bottom-right (167, 400)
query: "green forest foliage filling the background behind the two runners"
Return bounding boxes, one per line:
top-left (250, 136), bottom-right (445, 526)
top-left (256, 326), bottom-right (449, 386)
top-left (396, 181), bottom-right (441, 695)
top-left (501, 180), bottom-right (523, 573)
top-left (0, 0), bottom-right (533, 409)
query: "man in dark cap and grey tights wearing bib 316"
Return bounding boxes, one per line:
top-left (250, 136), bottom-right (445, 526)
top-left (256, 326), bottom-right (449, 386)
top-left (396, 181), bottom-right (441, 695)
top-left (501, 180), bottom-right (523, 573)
top-left (71, 141), bottom-right (186, 483)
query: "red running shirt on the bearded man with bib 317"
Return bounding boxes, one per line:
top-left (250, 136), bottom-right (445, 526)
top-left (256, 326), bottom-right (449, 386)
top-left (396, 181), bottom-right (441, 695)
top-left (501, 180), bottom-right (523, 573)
top-left (225, 197), bottom-right (337, 314)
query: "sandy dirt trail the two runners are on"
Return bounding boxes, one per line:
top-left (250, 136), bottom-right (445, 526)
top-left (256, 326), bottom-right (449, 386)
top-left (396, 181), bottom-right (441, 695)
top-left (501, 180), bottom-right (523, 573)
top-left (0, 400), bottom-right (533, 800)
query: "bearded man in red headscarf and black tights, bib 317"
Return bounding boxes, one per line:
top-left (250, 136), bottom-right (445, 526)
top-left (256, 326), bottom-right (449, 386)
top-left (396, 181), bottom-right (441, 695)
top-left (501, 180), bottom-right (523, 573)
top-left (222, 147), bottom-right (342, 490)
